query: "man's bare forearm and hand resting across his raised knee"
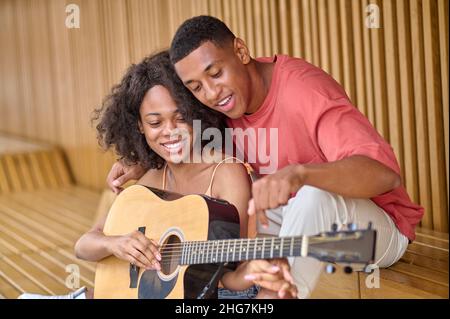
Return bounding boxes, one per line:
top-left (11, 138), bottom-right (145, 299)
top-left (248, 155), bottom-right (401, 225)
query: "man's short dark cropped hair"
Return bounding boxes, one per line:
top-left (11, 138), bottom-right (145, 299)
top-left (170, 15), bottom-right (235, 64)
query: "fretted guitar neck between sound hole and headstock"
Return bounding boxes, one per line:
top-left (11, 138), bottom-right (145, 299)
top-left (176, 236), bottom-right (308, 265)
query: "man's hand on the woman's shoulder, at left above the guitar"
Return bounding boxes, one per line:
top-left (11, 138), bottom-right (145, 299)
top-left (106, 160), bottom-right (145, 194)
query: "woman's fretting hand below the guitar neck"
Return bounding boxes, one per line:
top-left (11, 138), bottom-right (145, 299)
top-left (244, 259), bottom-right (297, 298)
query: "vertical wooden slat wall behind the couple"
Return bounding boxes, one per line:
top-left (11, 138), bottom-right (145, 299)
top-left (0, 0), bottom-right (449, 232)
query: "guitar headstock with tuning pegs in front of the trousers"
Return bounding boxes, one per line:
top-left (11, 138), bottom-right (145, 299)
top-left (308, 223), bottom-right (376, 265)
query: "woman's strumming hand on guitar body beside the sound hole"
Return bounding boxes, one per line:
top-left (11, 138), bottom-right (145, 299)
top-left (109, 230), bottom-right (161, 270)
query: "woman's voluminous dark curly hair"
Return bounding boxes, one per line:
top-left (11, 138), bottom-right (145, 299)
top-left (92, 51), bottom-right (225, 169)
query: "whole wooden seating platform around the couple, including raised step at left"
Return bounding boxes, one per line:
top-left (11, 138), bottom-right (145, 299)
top-left (0, 131), bottom-right (449, 299)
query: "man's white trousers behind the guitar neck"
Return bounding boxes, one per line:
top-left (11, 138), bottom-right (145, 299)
top-left (258, 186), bottom-right (408, 298)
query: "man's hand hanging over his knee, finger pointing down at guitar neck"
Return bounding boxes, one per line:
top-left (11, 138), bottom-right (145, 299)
top-left (248, 165), bottom-right (303, 227)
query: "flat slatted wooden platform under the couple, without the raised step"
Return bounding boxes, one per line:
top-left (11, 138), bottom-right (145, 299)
top-left (0, 186), bottom-right (449, 299)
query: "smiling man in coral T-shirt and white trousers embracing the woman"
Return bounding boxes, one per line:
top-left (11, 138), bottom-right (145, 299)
top-left (108, 16), bottom-right (423, 298)
